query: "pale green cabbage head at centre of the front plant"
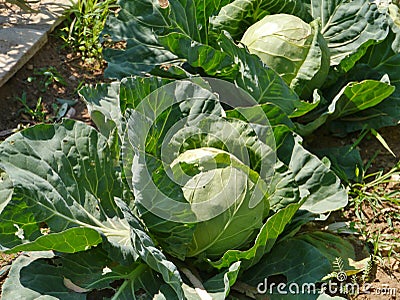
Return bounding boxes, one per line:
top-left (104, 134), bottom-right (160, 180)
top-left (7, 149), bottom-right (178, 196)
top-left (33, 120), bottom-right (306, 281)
top-left (171, 147), bottom-right (269, 258)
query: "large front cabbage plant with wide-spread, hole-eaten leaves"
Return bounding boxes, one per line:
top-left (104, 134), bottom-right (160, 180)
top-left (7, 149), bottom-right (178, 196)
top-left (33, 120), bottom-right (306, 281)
top-left (0, 77), bottom-right (354, 299)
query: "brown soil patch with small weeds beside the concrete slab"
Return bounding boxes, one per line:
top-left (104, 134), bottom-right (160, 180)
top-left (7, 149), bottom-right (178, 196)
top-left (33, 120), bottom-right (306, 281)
top-left (0, 35), bottom-right (106, 135)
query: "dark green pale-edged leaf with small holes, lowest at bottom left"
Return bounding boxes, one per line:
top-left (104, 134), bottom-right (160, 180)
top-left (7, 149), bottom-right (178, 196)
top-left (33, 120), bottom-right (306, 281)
top-left (2, 248), bottom-right (176, 300)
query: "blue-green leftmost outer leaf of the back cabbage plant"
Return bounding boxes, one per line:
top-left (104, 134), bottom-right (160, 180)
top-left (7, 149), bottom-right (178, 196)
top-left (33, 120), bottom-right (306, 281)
top-left (103, 0), bottom-right (178, 78)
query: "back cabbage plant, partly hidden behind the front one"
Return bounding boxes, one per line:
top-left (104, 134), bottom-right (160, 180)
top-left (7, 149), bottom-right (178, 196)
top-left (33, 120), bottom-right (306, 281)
top-left (99, 0), bottom-right (400, 181)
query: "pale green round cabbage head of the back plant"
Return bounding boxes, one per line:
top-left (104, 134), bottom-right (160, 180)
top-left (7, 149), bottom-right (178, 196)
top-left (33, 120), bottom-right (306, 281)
top-left (241, 14), bottom-right (330, 98)
